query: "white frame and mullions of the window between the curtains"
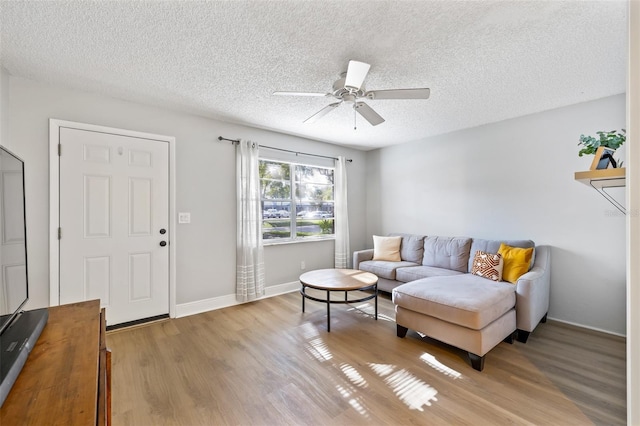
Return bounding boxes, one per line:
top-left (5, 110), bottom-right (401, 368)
top-left (259, 156), bottom-right (336, 246)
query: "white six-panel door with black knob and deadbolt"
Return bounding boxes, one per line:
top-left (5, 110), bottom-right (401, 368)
top-left (59, 127), bottom-right (169, 325)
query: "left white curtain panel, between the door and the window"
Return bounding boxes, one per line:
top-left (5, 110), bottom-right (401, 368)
top-left (236, 140), bottom-right (264, 302)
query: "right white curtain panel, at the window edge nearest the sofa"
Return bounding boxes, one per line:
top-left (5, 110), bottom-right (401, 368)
top-left (334, 157), bottom-right (351, 268)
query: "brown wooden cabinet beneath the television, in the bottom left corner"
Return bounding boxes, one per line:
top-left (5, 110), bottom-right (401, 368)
top-left (0, 300), bottom-right (111, 426)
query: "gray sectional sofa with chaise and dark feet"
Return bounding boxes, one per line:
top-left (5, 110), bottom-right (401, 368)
top-left (353, 234), bottom-right (551, 371)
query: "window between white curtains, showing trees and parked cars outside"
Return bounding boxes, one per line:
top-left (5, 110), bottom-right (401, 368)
top-left (259, 160), bottom-right (335, 241)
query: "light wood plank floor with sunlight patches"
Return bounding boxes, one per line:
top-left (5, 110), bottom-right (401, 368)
top-left (107, 293), bottom-right (626, 425)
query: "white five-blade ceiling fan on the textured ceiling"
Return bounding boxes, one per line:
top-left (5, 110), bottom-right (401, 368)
top-left (273, 61), bottom-right (431, 129)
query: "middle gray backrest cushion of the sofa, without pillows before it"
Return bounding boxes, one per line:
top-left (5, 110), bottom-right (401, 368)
top-left (422, 237), bottom-right (472, 272)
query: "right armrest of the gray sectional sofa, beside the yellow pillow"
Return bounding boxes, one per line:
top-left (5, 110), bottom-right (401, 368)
top-left (516, 246), bottom-right (551, 332)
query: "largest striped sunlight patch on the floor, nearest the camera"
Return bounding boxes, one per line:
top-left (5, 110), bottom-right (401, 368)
top-left (369, 363), bottom-right (438, 411)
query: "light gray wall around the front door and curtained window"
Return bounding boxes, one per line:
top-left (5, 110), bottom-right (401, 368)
top-left (6, 76), bottom-right (366, 309)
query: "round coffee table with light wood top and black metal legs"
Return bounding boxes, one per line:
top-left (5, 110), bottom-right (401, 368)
top-left (300, 269), bottom-right (378, 332)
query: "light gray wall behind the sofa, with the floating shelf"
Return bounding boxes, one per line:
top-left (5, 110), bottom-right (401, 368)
top-left (367, 95), bottom-right (626, 334)
